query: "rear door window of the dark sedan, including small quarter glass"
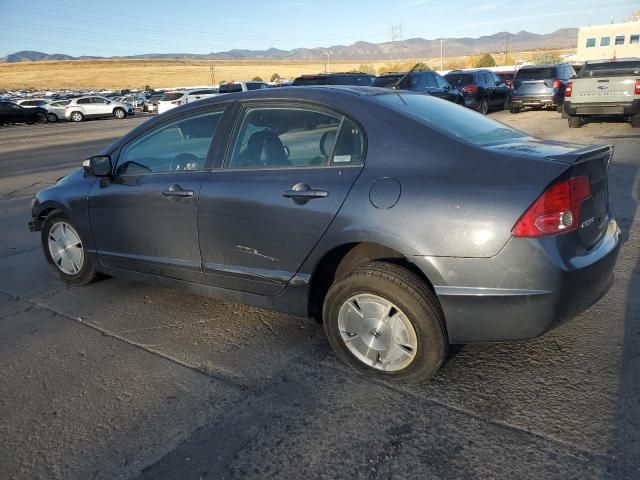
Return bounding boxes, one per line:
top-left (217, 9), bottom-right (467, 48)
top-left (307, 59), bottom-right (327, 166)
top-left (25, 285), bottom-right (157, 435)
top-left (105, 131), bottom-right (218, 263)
top-left (225, 107), bottom-right (364, 169)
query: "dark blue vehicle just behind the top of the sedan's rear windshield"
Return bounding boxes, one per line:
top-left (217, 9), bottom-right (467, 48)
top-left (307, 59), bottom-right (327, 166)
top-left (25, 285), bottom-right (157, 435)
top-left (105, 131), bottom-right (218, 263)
top-left (373, 70), bottom-right (464, 105)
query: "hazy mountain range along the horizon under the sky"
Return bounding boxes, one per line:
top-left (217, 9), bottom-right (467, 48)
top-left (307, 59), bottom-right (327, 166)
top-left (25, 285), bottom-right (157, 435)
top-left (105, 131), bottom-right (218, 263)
top-left (0, 28), bottom-right (578, 63)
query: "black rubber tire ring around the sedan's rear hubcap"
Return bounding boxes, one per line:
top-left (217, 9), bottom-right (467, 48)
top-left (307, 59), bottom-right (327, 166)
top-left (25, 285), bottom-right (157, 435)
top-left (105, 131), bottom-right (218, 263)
top-left (322, 261), bottom-right (449, 383)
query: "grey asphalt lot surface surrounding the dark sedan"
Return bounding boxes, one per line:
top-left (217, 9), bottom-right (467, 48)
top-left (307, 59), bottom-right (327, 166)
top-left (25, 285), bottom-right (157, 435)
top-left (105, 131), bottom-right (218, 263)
top-left (0, 112), bottom-right (640, 480)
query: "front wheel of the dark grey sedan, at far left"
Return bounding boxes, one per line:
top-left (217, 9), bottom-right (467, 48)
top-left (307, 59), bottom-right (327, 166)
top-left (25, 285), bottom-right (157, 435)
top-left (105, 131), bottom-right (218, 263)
top-left (42, 213), bottom-right (97, 285)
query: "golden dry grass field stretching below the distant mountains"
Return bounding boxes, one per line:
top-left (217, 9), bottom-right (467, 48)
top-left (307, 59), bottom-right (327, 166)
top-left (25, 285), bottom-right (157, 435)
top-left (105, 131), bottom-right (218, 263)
top-left (0, 60), bottom-right (435, 89)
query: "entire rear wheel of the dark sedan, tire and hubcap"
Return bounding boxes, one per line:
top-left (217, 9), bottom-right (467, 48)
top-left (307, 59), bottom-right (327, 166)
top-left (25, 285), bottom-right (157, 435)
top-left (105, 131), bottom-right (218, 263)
top-left (322, 262), bottom-right (449, 383)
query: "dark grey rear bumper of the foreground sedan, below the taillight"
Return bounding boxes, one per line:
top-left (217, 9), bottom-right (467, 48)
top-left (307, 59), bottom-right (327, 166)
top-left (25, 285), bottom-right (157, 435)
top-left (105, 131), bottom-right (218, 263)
top-left (415, 220), bottom-right (620, 343)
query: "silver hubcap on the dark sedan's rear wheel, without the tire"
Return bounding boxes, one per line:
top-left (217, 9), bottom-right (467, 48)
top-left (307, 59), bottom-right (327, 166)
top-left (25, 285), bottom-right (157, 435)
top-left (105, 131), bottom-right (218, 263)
top-left (338, 294), bottom-right (418, 372)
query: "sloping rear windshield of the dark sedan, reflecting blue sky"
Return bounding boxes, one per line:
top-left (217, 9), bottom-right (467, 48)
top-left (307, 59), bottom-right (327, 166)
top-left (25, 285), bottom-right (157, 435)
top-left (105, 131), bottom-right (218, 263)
top-left (374, 93), bottom-right (527, 145)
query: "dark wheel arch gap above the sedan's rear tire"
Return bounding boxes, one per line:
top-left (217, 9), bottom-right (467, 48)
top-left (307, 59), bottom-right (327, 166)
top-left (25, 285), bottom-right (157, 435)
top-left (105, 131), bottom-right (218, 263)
top-left (307, 242), bottom-right (435, 323)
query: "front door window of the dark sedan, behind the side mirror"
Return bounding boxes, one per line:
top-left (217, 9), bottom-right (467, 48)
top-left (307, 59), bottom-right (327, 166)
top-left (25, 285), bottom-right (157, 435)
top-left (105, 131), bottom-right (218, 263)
top-left (116, 110), bottom-right (223, 175)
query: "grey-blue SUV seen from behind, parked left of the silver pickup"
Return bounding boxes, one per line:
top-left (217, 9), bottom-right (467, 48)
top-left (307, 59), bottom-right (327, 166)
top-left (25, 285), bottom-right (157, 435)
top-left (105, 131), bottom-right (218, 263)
top-left (511, 63), bottom-right (576, 113)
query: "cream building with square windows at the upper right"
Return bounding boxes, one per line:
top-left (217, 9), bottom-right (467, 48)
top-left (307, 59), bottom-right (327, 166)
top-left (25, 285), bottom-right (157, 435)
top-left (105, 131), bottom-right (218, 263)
top-left (573, 17), bottom-right (640, 61)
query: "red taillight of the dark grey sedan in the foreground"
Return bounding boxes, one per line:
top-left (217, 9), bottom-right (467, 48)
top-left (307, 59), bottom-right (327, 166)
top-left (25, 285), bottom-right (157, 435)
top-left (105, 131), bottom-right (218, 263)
top-left (511, 176), bottom-right (591, 237)
